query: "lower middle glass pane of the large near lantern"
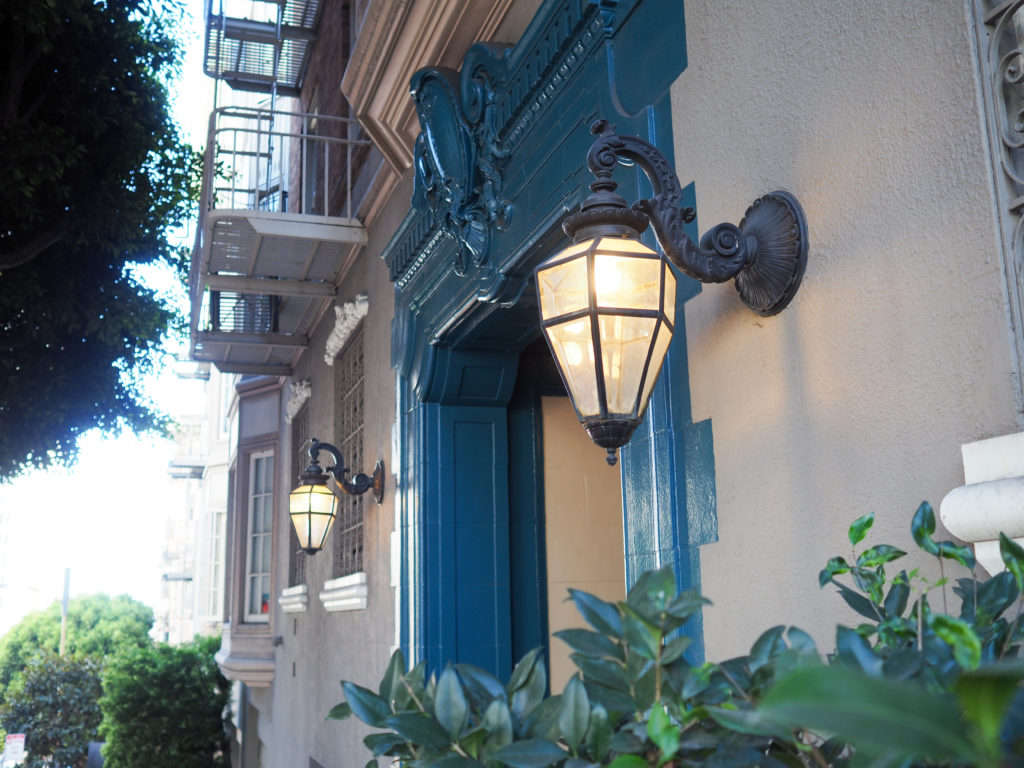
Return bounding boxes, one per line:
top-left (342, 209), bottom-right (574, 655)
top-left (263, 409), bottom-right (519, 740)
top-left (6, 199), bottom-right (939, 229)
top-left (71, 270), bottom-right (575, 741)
top-left (598, 314), bottom-right (657, 415)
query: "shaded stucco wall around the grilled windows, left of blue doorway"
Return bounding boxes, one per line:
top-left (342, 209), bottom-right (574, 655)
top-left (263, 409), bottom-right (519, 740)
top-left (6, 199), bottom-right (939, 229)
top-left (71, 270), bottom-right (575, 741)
top-left (253, 173), bottom-right (412, 768)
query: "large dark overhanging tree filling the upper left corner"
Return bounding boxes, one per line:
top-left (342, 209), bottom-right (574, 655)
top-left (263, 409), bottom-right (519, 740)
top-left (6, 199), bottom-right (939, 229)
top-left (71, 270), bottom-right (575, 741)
top-left (0, 0), bottom-right (198, 478)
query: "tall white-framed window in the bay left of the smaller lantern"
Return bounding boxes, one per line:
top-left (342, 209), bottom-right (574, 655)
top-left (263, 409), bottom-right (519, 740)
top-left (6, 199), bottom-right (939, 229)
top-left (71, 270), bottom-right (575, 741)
top-left (245, 451), bottom-right (273, 622)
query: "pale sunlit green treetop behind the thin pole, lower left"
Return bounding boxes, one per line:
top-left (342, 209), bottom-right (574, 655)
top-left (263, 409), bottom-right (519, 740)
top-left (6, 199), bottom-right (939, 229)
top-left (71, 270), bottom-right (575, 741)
top-left (0, 595), bottom-right (153, 689)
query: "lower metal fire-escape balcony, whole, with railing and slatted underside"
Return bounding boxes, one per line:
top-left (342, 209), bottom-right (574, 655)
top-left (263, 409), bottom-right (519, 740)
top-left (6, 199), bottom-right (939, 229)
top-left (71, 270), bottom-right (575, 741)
top-left (189, 106), bottom-right (370, 376)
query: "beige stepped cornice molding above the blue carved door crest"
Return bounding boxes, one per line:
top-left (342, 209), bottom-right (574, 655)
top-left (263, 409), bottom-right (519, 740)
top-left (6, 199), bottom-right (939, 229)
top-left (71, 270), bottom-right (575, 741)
top-left (341, 0), bottom-right (513, 174)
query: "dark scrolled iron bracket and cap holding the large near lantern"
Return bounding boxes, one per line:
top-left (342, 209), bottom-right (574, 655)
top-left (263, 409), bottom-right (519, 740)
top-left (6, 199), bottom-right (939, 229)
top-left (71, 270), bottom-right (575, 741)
top-left (562, 120), bottom-right (807, 316)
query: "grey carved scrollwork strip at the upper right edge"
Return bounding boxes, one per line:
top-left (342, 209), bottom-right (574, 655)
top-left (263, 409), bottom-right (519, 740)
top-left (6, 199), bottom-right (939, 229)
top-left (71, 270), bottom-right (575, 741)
top-left (974, 0), bottom-right (1024, 413)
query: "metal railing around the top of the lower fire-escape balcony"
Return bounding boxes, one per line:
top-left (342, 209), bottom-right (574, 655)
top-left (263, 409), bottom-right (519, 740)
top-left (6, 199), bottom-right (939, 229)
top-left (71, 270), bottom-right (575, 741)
top-left (200, 106), bottom-right (370, 223)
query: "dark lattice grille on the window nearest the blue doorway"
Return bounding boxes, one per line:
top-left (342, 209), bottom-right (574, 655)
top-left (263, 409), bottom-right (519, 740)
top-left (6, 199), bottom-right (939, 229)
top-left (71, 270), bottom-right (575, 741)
top-left (333, 326), bottom-right (367, 577)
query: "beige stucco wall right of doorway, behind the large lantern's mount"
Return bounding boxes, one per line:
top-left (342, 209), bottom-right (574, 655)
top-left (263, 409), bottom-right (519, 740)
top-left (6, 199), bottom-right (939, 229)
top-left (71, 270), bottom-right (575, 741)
top-left (672, 0), bottom-right (1019, 658)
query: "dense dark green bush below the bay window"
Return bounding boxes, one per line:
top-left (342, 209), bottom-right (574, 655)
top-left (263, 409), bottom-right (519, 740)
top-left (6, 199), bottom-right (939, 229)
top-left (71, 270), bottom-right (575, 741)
top-left (99, 637), bottom-right (228, 768)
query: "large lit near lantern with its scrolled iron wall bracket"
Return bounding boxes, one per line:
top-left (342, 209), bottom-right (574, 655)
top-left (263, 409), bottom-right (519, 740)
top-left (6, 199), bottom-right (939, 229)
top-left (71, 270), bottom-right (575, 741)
top-left (537, 120), bottom-right (807, 465)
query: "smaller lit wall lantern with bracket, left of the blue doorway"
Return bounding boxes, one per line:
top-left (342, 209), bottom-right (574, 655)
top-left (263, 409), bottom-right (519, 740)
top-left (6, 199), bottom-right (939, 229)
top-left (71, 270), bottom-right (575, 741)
top-left (288, 438), bottom-right (384, 555)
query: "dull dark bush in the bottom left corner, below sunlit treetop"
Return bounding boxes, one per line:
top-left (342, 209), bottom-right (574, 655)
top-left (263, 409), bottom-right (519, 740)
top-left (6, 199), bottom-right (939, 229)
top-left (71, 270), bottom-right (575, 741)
top-left (0, 653), bottom-right (102, 768)
